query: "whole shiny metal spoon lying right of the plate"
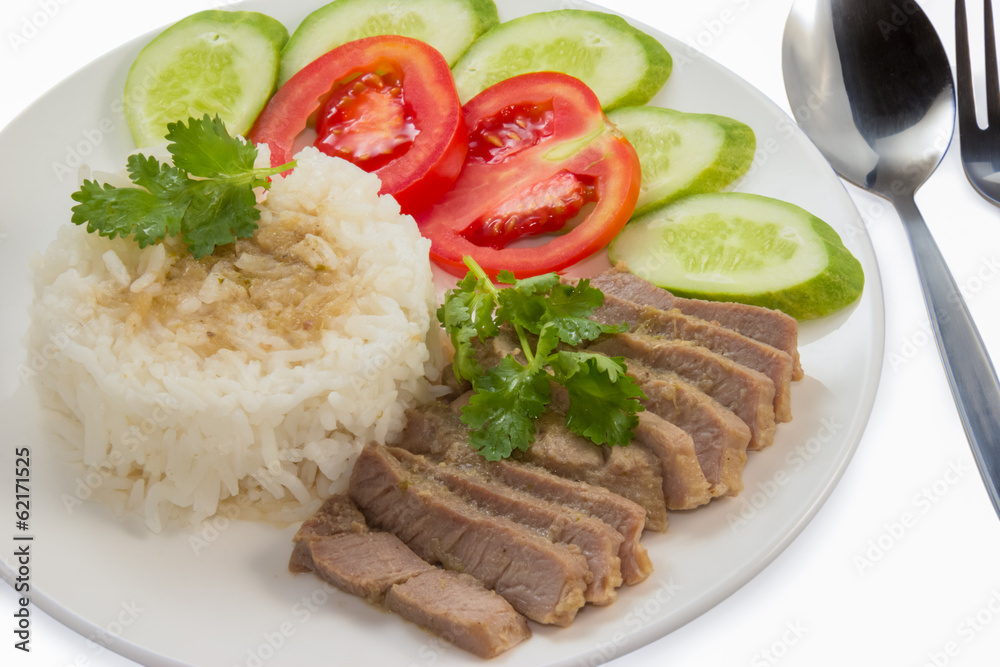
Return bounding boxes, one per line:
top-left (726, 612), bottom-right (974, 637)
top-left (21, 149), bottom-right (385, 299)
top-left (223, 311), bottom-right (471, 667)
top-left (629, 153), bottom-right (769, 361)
top-left (782, 0), bottom-right (1000, 514)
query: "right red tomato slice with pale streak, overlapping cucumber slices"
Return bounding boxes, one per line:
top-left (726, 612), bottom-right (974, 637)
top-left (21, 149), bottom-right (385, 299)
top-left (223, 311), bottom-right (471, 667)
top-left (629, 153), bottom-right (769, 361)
top-left (414, 72), bottom-right (640, 278)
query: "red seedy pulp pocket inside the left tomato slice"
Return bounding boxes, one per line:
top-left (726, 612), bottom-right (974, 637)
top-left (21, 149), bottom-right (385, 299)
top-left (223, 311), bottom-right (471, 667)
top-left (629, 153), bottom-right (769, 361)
top-left (313, 68), bottom-right (419, 171)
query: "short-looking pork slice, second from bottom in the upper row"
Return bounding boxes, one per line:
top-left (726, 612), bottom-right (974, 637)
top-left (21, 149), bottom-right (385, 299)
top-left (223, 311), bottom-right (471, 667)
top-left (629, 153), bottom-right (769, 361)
top-left (630, 410), bottom-right (713, 510)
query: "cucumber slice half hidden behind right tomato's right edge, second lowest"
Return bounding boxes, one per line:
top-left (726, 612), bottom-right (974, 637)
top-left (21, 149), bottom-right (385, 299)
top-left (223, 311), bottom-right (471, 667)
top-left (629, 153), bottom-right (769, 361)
top-left (608, 106), bottom-right (757, 216)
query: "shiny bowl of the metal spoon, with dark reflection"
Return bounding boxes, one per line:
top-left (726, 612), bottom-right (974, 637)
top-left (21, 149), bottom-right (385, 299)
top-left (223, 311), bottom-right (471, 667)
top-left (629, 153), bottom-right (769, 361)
top-left (782, 0), bottom-right (956, 199)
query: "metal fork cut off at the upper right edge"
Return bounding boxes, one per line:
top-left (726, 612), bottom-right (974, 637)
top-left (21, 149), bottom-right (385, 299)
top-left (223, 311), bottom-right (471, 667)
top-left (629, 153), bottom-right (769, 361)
top-left (955, 0), bottom-right (1000, 206)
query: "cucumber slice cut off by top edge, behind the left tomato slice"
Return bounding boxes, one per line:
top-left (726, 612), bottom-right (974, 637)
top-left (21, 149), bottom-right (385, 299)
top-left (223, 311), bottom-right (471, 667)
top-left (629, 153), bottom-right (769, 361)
top-left (278, 0), bottom-right (500, 85)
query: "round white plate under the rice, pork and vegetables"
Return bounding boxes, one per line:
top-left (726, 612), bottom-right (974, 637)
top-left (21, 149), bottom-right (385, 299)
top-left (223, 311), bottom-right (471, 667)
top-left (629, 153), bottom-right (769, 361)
top-left (0, 0), bottom-right (884, 667)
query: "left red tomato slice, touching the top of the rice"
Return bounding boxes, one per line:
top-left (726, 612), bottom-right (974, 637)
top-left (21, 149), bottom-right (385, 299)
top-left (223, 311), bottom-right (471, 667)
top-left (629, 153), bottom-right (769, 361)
top-left (249, 35), bottom-right (468, 213)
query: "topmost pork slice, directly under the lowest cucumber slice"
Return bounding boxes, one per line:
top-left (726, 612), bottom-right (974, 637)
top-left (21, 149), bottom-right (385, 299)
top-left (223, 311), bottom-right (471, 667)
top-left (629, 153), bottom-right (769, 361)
top-left (590, 267), bottom-right (803, 380)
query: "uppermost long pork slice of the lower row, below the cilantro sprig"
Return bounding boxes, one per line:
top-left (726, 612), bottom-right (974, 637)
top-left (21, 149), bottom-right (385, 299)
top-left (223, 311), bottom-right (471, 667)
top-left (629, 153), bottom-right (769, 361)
top-left (399, 402), bottom-right (653, 585)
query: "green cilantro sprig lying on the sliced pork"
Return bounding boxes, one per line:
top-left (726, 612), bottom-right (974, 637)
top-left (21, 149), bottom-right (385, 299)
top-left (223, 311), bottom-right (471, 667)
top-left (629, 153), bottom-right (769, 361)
top-left (438, 257), bottom-right (645, 461)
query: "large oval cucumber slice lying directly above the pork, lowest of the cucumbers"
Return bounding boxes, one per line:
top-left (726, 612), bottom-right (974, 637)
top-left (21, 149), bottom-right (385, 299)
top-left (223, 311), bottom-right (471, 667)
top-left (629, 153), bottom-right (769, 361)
top-left (609, 192), bottom-right (865, 320)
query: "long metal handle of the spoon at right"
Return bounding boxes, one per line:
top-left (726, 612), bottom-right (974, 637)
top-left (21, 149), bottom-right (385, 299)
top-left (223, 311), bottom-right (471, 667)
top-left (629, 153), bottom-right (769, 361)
top-left (893, 197), bottom-right (1000, 514)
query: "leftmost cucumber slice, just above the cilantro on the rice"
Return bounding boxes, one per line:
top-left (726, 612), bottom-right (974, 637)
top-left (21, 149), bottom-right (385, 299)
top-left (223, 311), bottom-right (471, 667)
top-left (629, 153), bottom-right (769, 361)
top-left (124, 9), bottom-right (288, 148)
